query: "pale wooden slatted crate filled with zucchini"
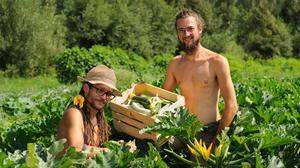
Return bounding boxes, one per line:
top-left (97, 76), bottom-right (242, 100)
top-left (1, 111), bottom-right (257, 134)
top-left (110, 83), bottom-right (182, 145)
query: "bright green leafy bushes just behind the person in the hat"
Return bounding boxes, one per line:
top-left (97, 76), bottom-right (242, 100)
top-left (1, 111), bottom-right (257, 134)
top-left (55, 45), bottom-right (150, 83)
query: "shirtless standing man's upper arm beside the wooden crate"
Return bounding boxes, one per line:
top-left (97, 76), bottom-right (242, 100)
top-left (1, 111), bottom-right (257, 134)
top-left (163, 60), bottom-right (177, 92)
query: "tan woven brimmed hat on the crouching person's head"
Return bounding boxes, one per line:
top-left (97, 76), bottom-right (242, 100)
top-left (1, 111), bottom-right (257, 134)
top-left (77, 65), bottom-right (122, 96)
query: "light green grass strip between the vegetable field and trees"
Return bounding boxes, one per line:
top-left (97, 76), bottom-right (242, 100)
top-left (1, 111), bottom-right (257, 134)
top-left (0, 56), bottom-right (300, 93)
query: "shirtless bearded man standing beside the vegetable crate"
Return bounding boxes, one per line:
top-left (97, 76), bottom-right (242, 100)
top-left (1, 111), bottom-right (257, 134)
top-left (163, 9), bottom-right (238, 143)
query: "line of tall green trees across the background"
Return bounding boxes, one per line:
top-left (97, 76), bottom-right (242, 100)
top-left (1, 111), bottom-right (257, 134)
top-left (0, 0), bottom-right (300, 76)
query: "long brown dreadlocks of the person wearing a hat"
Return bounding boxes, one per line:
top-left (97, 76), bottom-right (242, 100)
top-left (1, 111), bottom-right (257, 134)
top-left (79, 87), bottom-right (111, 147)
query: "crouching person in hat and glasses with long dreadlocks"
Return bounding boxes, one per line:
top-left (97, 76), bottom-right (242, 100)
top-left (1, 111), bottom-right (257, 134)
top-left (58, 65), bottom-right (121, 154)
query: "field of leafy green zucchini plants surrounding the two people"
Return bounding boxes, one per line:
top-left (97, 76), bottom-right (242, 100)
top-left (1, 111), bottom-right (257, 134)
top-left (0, 78), bottom-right (300, 168)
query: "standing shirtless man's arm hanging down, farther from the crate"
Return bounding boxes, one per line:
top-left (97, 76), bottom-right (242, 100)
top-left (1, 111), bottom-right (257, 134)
top-left (215, 56), bottom-right (238, 133)
